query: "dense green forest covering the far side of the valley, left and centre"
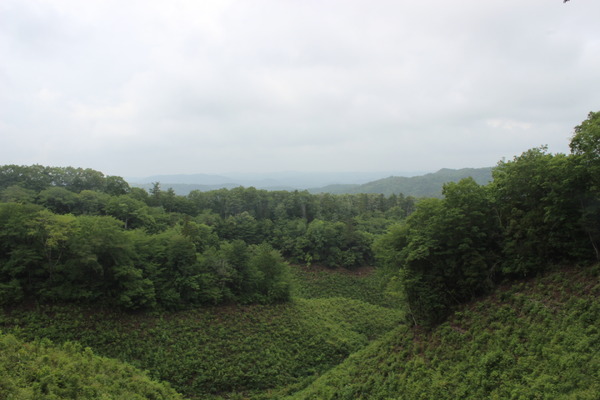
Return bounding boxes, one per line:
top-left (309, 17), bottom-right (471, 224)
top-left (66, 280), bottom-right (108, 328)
top-left (0, 165), bottom-right (415, 309)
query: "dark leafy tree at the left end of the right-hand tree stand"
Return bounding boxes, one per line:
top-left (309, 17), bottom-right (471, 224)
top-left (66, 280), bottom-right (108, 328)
top-left (378, 179), bottom-right (499, 325)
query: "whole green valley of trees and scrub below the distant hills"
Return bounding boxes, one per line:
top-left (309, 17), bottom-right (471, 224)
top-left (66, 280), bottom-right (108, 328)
top-left (0, 112), bottom-right (600, 400)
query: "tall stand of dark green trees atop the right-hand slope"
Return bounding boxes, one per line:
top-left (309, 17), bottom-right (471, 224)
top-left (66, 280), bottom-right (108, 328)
top-left (374, 113), bottom-right (600, 326)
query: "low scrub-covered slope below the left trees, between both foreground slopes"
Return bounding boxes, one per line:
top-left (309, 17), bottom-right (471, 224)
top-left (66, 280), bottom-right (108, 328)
top-left (0, 298), bottom-right (401, 399)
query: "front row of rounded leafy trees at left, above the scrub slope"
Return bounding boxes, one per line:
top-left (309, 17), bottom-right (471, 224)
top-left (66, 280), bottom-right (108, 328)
top-left (0, 203), bottom-right (289, 309)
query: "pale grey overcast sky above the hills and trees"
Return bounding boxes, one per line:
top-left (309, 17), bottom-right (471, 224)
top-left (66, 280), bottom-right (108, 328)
top-left (0, 0), bottom-right (600, 176)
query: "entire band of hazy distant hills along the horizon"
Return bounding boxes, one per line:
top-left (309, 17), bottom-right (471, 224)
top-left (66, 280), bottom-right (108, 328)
top-left (126, 167), bottom-right (492, 197)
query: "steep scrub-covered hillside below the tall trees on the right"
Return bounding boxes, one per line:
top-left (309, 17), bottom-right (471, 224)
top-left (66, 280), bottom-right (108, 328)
top-left (289, 267), bottom-right (600, 400)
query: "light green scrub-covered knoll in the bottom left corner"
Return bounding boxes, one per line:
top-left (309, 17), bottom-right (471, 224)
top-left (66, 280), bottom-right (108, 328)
top-left (0, 333), bottom-right (183, 400)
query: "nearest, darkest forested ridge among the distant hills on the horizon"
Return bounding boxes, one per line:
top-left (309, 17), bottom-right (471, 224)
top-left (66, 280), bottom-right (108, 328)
top-left (309, 167), bottom-right (492, 197)
